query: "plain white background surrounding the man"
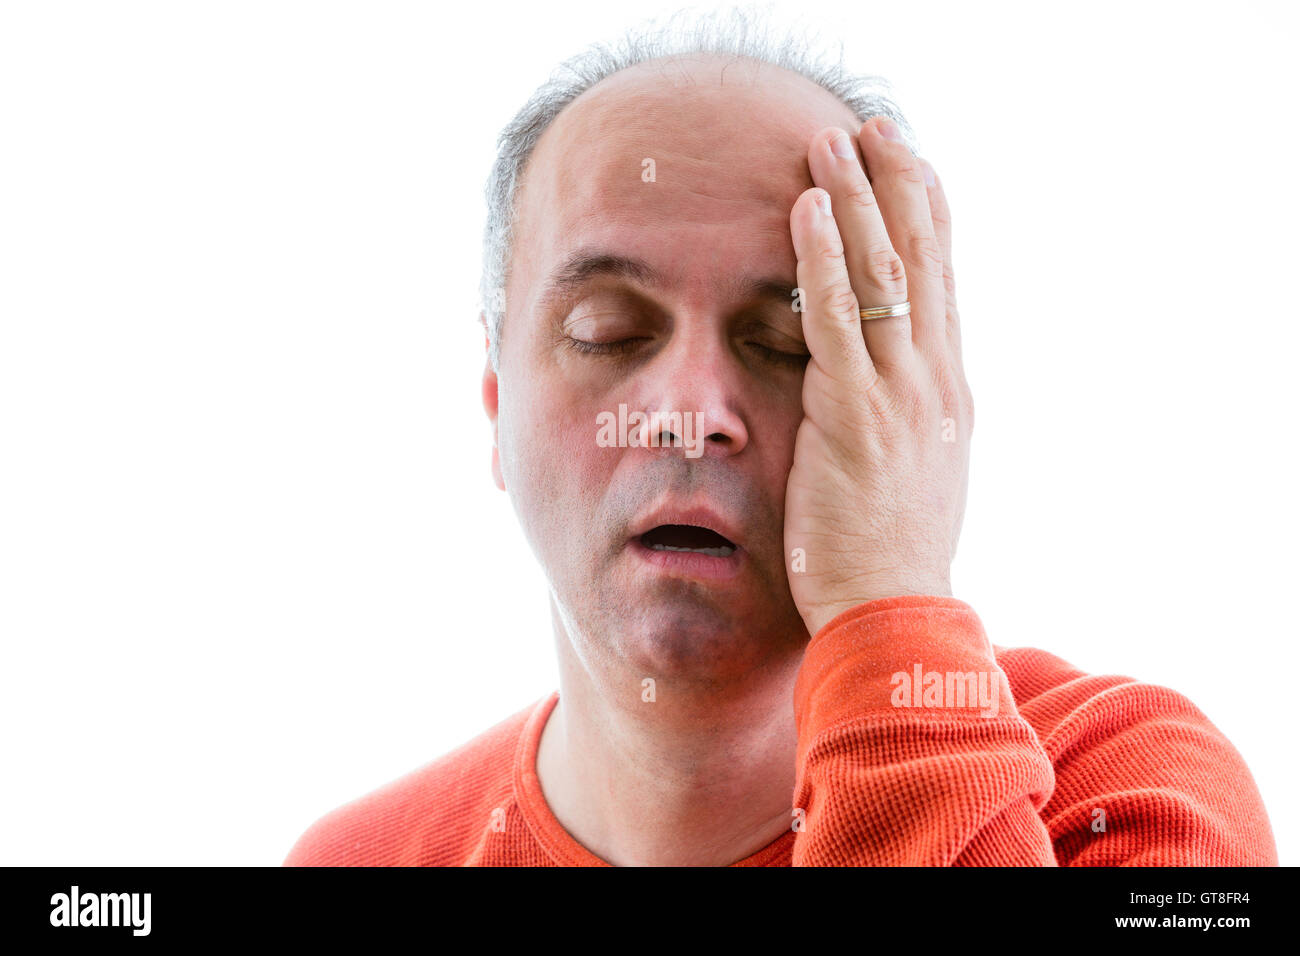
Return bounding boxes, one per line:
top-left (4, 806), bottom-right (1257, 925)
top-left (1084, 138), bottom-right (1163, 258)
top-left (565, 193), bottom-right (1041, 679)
top-left (0, 0), bottom-right (1300, 865)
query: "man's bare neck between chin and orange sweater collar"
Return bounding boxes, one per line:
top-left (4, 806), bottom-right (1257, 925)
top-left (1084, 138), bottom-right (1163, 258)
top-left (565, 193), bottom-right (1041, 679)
top-left (537, 604), bottom-right (800, 866)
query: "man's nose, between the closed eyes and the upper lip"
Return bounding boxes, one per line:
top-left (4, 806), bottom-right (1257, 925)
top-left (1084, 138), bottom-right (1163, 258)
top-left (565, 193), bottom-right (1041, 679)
top-left (640, 323), bottom-right (749, 458)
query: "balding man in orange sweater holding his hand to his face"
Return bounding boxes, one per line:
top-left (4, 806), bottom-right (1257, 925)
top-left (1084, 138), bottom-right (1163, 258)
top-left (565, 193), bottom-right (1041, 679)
top-left (286, 14), bottom-right (1277, 866)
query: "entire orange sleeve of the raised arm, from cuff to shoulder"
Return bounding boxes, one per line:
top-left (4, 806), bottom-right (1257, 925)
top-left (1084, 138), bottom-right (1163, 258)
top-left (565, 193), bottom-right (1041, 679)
top-left (793, 596), bottom-right (1277, 866)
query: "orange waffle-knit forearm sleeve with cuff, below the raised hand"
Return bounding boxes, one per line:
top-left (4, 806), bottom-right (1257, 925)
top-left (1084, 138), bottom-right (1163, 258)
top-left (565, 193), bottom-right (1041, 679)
top-left (793, 596), bottom-right (1056, 866)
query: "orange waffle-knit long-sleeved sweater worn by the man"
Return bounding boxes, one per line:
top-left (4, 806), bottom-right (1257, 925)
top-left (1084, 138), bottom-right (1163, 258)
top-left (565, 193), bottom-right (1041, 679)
top-left (285, 597), bottom-right (1277, 866)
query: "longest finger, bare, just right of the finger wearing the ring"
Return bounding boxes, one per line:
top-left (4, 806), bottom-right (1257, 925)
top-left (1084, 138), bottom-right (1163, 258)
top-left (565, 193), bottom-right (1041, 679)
top-left (858, 117), bottom-right (948, 354)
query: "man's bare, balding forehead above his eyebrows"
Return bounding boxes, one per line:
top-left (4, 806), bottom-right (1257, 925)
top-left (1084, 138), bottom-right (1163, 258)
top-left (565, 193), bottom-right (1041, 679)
top-left (515, 57), bottom-right (861, 299)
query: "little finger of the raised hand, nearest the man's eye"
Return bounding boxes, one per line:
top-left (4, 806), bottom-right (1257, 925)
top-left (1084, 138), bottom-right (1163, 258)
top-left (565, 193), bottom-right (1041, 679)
top-left (790, 187), bottom-right (876, 389)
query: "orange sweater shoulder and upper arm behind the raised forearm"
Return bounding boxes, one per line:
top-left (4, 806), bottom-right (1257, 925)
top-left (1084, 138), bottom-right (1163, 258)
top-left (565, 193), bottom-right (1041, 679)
top-left (993, 646), bottom-right (1277, 866)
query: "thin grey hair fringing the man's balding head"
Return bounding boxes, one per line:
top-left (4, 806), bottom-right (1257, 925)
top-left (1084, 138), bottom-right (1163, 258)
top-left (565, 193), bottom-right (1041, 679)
top-left (478, 8), bottom-right (917, 371)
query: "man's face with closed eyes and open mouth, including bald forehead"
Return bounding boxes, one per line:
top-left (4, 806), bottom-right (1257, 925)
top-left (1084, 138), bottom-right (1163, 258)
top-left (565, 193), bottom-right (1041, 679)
top-left (484, 57), bottom-right (859, 683)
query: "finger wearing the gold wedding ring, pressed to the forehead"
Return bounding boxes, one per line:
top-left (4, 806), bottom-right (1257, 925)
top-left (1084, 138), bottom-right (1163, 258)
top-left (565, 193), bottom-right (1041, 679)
top-left (809, 127), bottom-right (913, 375)
